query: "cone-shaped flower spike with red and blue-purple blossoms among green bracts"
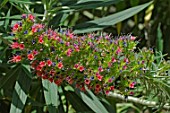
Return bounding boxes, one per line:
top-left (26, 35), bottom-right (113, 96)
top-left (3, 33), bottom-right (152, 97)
top-left (10, 14), bottom-right (153, 95)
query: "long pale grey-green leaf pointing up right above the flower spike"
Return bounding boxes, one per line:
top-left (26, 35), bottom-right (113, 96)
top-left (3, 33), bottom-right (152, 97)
top-left (74, 2), bottom-right (152, 34)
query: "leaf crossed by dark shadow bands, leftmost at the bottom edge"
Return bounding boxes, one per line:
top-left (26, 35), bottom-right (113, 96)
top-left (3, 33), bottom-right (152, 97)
top-left (10, 67), bottom-right (31, 113)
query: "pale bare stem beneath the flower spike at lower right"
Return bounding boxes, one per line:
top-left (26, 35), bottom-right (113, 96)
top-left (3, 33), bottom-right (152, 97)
top-left (108, 93), bottom-right (170, 110)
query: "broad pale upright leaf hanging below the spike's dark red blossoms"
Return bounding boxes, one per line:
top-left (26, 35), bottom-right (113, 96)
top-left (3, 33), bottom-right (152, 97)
top-left (42, 80), bottom-right (60, 113)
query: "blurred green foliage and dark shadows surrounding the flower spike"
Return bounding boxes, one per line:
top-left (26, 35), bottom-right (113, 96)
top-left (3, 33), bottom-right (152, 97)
top-left (0, 0), bottom-right (170, 113)
